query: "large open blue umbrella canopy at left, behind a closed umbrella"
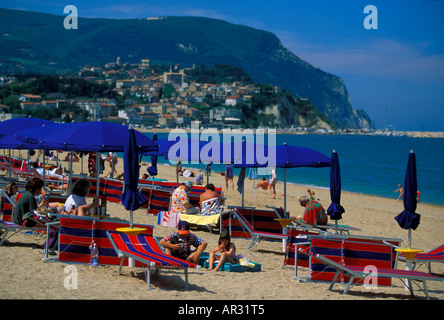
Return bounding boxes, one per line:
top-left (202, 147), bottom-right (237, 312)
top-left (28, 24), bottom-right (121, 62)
top-left (17, 121), bottom-right (158, 152)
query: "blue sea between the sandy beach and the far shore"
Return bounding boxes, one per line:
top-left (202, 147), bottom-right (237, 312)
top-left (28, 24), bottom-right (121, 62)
top-left (139, 133), bottom-right (444, 206)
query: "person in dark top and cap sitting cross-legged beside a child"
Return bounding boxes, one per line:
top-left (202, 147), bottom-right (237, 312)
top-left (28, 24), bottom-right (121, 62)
top-left (159, 221), bottom-right (207, 263)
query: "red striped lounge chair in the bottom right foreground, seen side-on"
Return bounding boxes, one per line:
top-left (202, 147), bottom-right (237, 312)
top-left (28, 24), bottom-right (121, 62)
top-left (299, 248), bottom-right (443, 300)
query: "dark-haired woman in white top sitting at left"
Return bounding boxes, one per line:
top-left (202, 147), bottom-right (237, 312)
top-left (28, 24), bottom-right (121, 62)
top-left (63, 179), bottom-right (99, 216)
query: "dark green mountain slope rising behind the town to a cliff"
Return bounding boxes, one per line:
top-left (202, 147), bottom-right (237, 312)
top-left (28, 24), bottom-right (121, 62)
top-left (0, 9), bottom-right (373, 128)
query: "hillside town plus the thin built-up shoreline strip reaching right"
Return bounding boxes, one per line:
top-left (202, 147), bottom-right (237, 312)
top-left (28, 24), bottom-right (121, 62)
top-left (0, 58), bottom-right (425, 137)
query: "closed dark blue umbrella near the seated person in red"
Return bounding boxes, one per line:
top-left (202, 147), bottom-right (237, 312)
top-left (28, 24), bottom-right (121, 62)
top-left (327, 151), bottom-right (345, 220)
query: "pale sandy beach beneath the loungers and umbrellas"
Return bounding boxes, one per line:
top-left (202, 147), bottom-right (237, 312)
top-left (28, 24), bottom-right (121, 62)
top-left (0, 152), bottom-right (444, 302)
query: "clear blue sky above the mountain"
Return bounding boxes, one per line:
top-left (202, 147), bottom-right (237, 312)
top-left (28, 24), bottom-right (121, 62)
top-left (0, 0), bottom-right (444, 131)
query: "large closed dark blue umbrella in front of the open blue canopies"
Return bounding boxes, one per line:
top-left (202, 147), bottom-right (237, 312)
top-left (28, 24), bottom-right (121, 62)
top-left (120, 129), bottom-right (147, 211)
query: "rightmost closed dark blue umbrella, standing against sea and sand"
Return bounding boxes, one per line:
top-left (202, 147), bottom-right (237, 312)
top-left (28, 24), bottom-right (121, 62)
top-left (395, 151), bottom-right (421, 230)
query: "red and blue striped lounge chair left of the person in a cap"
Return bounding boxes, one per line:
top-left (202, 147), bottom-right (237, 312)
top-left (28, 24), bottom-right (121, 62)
top-left (107, 231), bottom-right (200, 290)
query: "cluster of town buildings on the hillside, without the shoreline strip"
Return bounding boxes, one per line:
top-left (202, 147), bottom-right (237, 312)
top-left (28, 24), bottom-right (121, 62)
top-left (0, 58), bottom-right (280, 128)
